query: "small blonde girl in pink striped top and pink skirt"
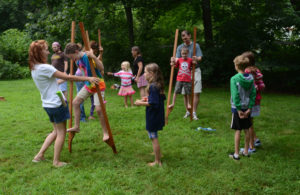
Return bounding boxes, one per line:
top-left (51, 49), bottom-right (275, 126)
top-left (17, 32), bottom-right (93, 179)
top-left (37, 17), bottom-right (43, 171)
top-left (107, 61), bottom-right (135, 108)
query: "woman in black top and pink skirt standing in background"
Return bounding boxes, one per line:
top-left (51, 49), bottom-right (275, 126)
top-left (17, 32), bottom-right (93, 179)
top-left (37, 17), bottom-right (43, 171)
top-left (131, 46), bottom-right (148, 98)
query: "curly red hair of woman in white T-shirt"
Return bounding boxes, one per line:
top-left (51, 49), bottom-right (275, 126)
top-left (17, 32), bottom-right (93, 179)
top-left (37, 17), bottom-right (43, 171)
top-left (28, 40), bottom-right (48, 70)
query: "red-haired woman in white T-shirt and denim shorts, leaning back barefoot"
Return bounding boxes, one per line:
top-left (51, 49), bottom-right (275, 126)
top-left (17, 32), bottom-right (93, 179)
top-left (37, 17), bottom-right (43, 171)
top-left (28, 40), bottom-right (99, 167)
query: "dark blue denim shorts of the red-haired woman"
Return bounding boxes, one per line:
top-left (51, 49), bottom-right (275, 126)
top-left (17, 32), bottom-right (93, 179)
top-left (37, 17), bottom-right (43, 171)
top-left (44, 105), bottom-right (70, 123)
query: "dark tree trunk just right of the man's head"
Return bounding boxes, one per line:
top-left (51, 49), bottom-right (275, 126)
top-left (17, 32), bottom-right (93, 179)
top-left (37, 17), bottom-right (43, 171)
top-left (202, 0), bottom-right (213, 47)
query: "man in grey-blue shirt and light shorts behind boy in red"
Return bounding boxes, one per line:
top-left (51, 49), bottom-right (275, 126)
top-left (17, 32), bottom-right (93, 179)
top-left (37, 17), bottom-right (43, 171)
top-left (176, 30), bottom-right (203, 120)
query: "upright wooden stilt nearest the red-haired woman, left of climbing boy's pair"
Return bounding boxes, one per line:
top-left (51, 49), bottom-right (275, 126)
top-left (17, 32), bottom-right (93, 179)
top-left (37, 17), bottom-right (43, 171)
top-left (68, 21), bottom-right (75, 152)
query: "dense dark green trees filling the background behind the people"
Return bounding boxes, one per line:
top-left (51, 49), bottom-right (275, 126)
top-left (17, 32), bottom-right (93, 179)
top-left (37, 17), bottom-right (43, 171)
top-left (2, 0), bottom-right (300, 91)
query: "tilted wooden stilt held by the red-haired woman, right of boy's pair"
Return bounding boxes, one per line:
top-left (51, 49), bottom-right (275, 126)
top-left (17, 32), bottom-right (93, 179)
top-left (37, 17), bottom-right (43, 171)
top-left (79, 22), bottom-right (117, 153)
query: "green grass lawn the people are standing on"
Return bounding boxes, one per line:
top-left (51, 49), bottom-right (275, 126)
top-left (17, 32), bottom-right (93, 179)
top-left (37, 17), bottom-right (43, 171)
top-left (0, 80), bottom-right (300, 194)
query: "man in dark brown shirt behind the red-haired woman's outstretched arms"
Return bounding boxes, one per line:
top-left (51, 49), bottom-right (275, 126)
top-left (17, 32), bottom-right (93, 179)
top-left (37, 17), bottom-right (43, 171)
top-left (51, 42), bottom-right (68, 99)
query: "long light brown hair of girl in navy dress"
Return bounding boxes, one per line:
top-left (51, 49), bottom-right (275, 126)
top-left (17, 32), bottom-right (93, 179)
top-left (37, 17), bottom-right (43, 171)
top-left (145, 63), bottom-right (165, 94)
